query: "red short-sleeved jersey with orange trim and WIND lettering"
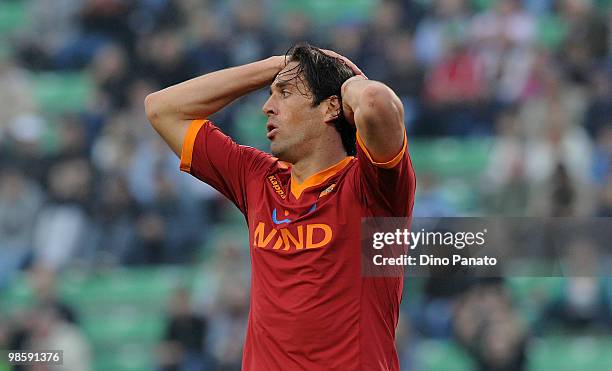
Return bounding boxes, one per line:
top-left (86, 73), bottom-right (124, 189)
top-left (181, 120), bottom-right (415, 371)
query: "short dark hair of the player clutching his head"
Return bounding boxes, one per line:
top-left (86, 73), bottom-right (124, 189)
top-left (285, 43), bottom-right (357, 156)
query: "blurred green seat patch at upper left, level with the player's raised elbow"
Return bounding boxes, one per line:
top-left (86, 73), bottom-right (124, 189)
top-left (32, 72), bottom-right (94, 114)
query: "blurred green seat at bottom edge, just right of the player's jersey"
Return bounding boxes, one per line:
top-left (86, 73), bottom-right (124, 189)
top-left (415, 340), bottom-right (475, 371)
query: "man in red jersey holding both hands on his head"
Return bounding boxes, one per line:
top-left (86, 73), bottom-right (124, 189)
top-left (145, 45), bottom-right (415, 371)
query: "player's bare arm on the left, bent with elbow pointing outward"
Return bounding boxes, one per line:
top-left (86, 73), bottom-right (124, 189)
top-left (145, 56), bottom-right (285, 156)
